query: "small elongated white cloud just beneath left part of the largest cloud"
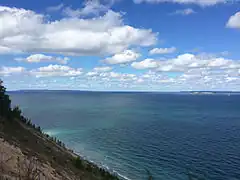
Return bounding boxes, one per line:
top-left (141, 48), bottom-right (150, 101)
top-left (15, 54), bottom-right (70, 64)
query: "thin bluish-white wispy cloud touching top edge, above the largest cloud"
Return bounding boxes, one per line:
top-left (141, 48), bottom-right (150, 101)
top-left (63, 0), bottom-right (109, 17)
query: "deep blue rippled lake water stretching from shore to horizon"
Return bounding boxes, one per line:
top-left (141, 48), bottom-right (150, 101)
top-left (7, 91), bottom-right (240, 180)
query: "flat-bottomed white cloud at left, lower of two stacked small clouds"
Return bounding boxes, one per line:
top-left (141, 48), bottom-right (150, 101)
top-left (29, 64), bottom-right (83, 77)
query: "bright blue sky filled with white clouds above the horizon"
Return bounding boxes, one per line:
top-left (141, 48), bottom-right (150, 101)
top-left (0, 0), bottom-right (240, 91)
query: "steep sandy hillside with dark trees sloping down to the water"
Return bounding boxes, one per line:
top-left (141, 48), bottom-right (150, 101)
top-left (0, 81), bottom-right (118, 180)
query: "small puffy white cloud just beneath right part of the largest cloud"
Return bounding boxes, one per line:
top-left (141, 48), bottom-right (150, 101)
top-left (103, 50), bottom-right (141, 64)
